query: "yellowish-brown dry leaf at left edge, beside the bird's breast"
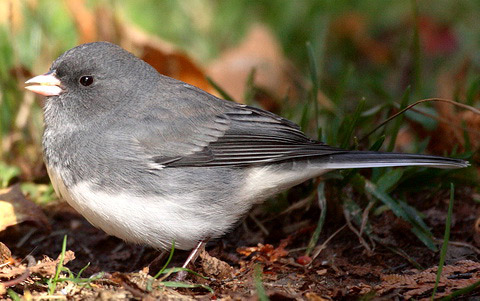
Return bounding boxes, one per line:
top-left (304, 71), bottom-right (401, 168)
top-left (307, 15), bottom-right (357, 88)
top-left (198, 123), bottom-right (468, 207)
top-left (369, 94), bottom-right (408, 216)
top-left (0, 185), bottom-right (50, 231)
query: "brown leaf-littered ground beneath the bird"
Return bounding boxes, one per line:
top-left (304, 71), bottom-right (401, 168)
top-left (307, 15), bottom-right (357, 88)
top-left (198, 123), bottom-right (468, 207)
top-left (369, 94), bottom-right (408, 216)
top-left (0, 183), bottom-right (480, 300)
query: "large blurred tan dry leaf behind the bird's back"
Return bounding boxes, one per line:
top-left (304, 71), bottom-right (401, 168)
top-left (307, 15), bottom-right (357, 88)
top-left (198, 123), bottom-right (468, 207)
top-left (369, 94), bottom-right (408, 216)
top-left (207, 24), bottom-right (298, 110)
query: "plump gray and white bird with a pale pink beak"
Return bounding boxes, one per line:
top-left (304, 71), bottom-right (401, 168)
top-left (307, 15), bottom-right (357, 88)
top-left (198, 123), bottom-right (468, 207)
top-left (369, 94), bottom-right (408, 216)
top-left (26, 42), bottom-right (468, 253)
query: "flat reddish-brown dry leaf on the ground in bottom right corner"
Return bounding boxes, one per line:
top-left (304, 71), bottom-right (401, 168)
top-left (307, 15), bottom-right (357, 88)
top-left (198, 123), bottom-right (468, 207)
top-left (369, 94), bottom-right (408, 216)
top-left (375, 260), bottom-right (480, 299)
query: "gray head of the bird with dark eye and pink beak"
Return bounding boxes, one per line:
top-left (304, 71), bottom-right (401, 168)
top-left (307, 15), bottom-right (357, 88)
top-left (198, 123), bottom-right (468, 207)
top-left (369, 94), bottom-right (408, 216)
top-left (26, 42), bottom-right (158, 126)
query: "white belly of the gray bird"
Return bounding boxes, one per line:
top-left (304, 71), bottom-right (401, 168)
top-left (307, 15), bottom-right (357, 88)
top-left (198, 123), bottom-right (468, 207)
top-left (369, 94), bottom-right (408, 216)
top-left (48, 164), bottom-right (231, 250)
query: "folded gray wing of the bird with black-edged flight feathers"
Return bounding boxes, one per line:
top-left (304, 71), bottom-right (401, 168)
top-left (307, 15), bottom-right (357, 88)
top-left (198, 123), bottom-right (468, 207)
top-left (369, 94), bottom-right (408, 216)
top-left (133, 82), bottom-right (346, 167)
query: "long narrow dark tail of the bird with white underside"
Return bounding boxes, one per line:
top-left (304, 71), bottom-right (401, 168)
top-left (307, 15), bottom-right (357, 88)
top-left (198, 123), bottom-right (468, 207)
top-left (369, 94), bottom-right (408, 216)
top-left (318, 151), bottom-right (470, 169)
